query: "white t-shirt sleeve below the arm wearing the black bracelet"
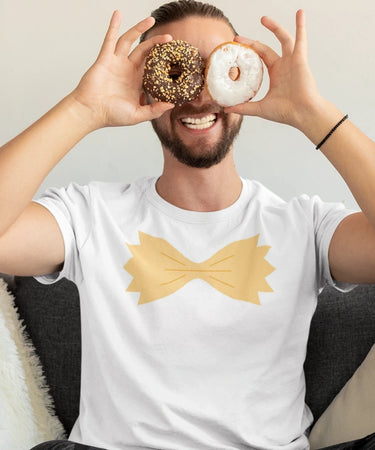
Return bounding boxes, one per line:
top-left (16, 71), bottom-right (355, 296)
top-left (312, 196), bottom-right (356, 292)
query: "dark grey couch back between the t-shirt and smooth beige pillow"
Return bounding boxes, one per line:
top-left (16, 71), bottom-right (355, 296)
top-left (305, 285), bottom-right (375, 420)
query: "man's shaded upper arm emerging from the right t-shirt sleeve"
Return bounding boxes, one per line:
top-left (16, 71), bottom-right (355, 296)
top-left (328, 213), bottom-right (375, 284)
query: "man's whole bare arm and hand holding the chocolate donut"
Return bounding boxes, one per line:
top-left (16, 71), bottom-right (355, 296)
top-left (0, 12), bottom-right (177, 275)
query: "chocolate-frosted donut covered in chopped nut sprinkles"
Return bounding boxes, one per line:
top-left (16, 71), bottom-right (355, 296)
top-left (143, 40), bottom-right (205, 105)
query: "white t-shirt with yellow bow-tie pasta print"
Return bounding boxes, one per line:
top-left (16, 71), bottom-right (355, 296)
top-left (39, 178), bottom-right (356, 450)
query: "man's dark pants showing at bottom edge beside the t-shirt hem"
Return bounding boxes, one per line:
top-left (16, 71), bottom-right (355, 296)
top-left (31, 433), bottom-right (375, 450)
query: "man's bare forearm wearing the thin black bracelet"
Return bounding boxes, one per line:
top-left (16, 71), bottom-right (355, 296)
top-left (299, 97), bottom-right (375, 227)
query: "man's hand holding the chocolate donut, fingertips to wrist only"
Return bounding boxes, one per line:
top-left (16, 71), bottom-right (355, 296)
top-left (71, 11), bottom-right (174, 130)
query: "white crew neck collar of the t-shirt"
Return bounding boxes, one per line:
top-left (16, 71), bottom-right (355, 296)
top-left (147, 177), bottom-right (249, 223)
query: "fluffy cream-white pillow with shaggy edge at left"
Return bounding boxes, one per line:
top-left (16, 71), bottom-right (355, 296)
top-left (0, 278), bottom-right (64, 450)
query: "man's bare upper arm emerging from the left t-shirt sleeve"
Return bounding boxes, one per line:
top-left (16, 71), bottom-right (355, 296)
top-left (0, 202), bottom-right (65, 276)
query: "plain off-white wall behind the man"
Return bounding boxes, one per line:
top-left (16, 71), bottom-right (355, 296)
top-left (0, 0), bottom-right (375, 207)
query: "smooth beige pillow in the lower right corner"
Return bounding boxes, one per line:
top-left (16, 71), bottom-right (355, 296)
top-left (309, 345), bottom-right (375, 450)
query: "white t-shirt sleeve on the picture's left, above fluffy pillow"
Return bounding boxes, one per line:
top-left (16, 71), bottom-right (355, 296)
top-left (34, 183), bottom-right (92, 284)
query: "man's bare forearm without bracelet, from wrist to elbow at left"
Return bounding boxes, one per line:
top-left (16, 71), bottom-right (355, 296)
top-left (0, 95), bottom-right (94, 236)
